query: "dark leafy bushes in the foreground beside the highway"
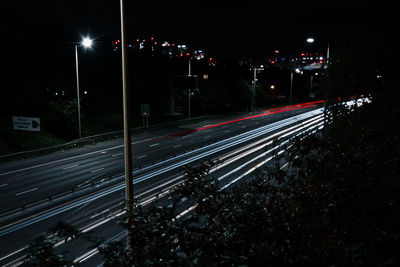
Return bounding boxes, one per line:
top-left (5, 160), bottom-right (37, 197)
top-left (97, 90), bottom-right (400, 266)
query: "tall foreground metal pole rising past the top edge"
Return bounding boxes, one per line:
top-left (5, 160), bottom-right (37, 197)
top-left (120, 0), bottom-right (133, 253)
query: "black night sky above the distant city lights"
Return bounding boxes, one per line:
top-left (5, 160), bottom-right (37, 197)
top-left (1, 0), bottom-right (392, 57)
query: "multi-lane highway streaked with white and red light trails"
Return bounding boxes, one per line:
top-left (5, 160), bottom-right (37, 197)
top-left (0, 102), bottom-right (323, 266)
